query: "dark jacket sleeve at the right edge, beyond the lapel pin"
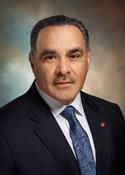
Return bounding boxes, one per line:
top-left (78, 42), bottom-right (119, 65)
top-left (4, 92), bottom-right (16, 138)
top-left (111, 105), bottom-right (125, 175)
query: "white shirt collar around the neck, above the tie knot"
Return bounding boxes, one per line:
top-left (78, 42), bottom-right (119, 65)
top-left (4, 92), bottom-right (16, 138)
top-left (35, 82), bottom-right (84, 117)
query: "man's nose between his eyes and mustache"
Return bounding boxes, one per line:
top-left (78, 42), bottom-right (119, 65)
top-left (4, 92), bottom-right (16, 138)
top-left (56, 58), bottom-right (70, 75)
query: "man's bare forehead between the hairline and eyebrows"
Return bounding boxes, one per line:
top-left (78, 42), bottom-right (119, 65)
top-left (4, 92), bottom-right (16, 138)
top-left (37, 25), bottom-right (84, 49)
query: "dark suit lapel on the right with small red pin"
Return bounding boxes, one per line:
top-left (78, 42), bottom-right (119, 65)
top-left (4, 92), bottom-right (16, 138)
top-left (82, 91), bottom-right (111, 175)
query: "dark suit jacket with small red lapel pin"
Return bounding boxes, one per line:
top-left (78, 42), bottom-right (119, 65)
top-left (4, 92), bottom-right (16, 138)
top-left (0, 84), bottom-right (125, 175)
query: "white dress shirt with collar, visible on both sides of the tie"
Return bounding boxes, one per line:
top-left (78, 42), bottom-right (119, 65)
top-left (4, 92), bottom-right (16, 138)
top-left (36, 83), bottom-right (96, 162)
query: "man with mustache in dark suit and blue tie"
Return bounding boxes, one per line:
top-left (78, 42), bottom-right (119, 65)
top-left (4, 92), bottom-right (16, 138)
top-left (0, 15), bottom-right (125, 175)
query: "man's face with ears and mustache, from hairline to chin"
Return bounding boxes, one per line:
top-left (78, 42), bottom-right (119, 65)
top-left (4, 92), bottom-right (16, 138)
top-left (30, 25), bottom-right (90, 104)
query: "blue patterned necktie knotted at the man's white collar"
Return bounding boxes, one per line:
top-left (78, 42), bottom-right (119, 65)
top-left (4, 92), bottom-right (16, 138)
top-left (61, 106), bottom-right (96, 175)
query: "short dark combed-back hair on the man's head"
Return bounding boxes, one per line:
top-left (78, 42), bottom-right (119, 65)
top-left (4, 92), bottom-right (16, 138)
top-left (30, 15), bottom-right (89, 53)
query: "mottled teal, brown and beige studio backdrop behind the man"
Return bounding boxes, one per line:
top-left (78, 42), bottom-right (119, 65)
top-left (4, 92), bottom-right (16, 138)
top-left (0, 0), bottom-right (125, 114)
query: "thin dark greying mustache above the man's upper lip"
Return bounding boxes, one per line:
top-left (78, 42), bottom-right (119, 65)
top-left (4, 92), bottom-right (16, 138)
top-left (53, 75), bottom-right (76, 85)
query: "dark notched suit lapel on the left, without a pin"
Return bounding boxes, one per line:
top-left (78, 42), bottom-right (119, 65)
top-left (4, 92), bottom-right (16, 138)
top-left (28, 85), bottom-right (79, 175)
